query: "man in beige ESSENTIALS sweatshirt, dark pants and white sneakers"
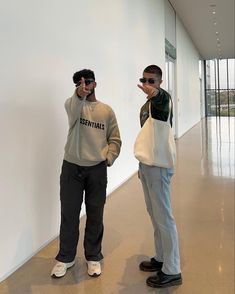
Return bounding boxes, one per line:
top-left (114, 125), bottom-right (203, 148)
top-left (51, 69), bottom-right (121, 278)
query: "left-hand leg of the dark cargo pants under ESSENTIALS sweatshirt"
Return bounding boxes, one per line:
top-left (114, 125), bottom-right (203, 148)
top-left (56, 161), bottom-right (84, 262)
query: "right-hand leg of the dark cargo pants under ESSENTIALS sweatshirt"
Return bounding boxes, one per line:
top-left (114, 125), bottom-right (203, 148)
top-left (84, 163), bottom-right (107, 261)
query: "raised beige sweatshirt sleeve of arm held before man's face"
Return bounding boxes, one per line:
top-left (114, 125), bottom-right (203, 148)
top-left (64, 92), bottom-right (82, 129)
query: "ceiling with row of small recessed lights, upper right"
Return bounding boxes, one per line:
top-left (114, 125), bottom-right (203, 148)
top-left (169, 0), bottom-right (235, 59)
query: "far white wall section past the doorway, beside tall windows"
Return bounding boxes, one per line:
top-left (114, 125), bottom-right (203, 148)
top-left (175, 17), bottom-right (201, 137)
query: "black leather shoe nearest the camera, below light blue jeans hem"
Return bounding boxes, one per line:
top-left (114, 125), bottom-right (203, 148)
top-left (146, 271), bottom-right (182, 288)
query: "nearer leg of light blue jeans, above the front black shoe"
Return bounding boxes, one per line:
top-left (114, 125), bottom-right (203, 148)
top-left (141, 164), bottom-right (181, 274)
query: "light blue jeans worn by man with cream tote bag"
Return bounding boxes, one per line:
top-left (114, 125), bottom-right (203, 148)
top-left (139, 163), bottom-right (181, 275)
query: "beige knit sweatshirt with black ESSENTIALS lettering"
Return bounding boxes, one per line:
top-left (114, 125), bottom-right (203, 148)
top-left (64, 92), bottom-right (121, 166)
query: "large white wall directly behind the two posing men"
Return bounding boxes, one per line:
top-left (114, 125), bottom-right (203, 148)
top-left (0, 0), bottom-right (165, 281)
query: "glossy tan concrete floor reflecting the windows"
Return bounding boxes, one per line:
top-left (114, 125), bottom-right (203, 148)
top-left (0, 118), bottom-right (234, 294)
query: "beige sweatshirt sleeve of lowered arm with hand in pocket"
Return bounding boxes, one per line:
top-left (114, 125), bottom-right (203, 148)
top-left (107, 110), bottom-right (122, 166)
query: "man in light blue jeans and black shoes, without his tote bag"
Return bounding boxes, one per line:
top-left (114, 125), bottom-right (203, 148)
top-left (138, 65), bottom-right (182, 288)
